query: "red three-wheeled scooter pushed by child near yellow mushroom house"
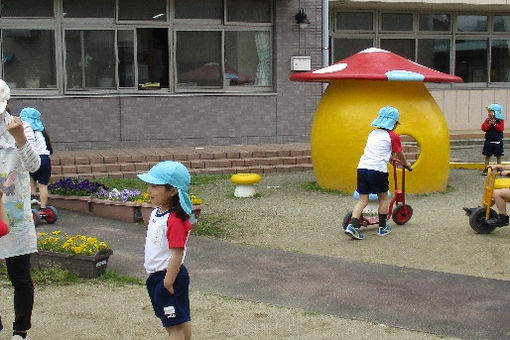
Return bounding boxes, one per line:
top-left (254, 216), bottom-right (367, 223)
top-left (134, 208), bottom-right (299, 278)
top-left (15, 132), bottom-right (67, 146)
top-left (342, 158), bottom-right (413, 230)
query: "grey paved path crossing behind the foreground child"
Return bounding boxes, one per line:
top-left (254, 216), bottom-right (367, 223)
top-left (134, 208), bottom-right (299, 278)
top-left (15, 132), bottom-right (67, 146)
top-left (38, 210), bottom-right (510, 339)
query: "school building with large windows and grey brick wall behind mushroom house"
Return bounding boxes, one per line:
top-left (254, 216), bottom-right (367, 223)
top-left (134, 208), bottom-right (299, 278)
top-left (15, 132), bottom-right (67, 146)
top-left (0, 0), bottom-right (510, 150)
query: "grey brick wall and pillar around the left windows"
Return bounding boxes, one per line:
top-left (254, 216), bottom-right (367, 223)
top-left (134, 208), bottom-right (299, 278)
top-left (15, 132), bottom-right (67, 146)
top-left (11, 0), bottom-right (321, 150)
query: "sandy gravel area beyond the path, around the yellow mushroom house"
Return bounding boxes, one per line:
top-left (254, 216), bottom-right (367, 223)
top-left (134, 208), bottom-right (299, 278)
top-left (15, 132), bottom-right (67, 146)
top-left (196, 170), bottom-right (510, 280)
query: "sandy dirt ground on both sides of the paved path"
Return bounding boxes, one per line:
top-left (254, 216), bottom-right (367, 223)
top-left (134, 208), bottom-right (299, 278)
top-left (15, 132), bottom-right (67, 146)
top-left (0, 170), bottom-right (498, 340)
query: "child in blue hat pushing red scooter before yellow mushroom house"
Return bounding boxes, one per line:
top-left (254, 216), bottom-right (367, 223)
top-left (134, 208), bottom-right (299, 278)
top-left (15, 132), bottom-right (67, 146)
top-left (344, 106), bottom-right (411, 240)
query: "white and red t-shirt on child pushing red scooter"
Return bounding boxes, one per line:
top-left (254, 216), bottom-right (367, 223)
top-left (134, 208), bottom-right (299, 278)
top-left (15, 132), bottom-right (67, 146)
top-left (358, 129), bottom-right (402, 172)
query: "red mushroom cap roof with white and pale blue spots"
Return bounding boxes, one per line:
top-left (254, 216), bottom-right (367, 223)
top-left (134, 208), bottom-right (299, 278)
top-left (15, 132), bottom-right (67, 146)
top-left (290, 47), bottom-right (462, 83)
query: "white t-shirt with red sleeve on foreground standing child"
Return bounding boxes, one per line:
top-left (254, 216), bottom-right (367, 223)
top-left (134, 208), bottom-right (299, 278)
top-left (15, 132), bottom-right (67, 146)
top-left (144, 208), bottom-right (191, 274)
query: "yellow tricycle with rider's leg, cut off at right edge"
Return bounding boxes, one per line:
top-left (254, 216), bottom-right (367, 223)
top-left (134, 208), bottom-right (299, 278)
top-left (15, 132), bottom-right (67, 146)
top-left (463, 164), bottom-right (510, 234)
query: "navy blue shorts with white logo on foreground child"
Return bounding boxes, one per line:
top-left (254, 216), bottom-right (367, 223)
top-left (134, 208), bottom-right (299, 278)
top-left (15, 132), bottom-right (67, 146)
top-left (146, 266), bottom-right (191, 327)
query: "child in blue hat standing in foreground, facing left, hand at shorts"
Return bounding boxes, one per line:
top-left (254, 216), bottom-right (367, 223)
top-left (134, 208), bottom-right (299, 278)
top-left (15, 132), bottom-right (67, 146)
top-left (138, 161), bottom-right (192, 340)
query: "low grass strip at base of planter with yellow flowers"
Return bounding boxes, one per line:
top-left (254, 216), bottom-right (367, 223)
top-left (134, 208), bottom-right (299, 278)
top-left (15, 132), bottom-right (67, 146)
top-left (0, 261), bottom-right (144, 286)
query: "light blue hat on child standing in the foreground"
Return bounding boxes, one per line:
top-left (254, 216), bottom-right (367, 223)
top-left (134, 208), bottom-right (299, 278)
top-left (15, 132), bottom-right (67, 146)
top-left (138, 161), bottom-right (192, 215)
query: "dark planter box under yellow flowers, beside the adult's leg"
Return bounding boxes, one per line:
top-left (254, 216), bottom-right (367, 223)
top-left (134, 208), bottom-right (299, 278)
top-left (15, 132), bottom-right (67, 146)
top-left (30, 249), bottom-right (113, 279)
